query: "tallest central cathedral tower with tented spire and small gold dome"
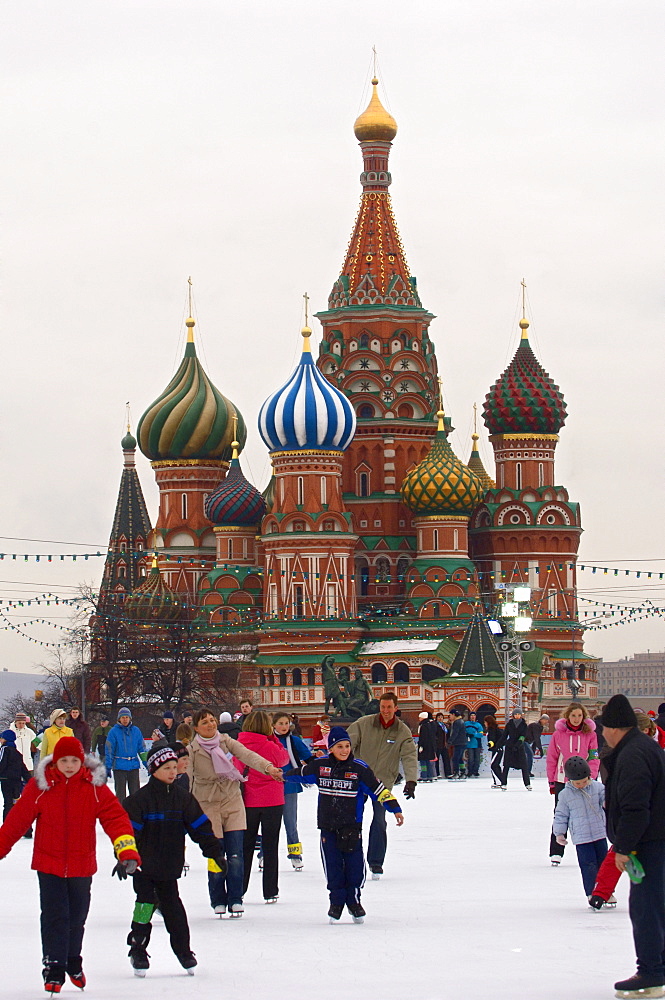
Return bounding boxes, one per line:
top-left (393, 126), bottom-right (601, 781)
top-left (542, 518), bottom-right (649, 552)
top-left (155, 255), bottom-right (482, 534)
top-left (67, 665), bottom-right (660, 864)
top-left (317, 77), bottom-right (437, 603)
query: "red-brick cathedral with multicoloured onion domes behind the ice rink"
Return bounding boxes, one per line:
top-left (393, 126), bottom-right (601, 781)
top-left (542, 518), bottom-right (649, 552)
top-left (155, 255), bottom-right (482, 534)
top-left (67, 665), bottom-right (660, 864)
top-left (93, 78), bottom-right (597, 731)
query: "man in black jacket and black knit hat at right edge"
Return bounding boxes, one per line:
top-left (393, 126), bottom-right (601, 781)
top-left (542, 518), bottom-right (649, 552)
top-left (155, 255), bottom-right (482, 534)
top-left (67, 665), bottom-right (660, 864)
top-left (601, 694), bottom-right (665, 997)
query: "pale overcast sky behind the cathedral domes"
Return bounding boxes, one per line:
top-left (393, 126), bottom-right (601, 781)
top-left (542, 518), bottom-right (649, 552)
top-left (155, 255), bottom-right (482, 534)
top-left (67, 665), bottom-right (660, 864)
top-left (0, 0), bottom-right (665, 670)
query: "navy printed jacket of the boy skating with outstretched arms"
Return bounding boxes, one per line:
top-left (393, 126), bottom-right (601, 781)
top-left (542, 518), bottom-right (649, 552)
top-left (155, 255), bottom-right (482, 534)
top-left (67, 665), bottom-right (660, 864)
top-left (285, 754), bottom-right (402, 830)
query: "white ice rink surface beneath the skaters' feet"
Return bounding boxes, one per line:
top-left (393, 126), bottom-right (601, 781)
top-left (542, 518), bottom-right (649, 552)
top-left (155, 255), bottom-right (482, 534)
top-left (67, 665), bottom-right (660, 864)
top-left (0, 765), bottom-right (635, 1000)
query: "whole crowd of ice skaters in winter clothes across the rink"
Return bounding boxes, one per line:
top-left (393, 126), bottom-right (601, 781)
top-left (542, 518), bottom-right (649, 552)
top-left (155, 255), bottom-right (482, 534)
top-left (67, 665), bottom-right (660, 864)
top-left (0, 692), bottom-right (665, 997)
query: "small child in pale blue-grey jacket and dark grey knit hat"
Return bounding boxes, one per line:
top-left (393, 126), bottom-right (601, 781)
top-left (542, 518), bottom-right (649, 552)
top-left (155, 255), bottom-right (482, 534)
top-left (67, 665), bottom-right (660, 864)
top-left (553, 757), bottom-right (607, 899)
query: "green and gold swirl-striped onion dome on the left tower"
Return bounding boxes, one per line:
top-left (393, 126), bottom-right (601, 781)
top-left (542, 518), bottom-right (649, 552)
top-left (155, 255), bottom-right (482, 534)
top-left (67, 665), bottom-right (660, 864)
top-left (137, 316), bottom-right (247, 462)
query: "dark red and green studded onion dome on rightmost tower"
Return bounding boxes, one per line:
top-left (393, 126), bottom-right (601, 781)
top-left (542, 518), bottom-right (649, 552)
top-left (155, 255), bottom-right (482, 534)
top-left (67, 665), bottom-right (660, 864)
top-left (483, 319), bottom-right (566, 434)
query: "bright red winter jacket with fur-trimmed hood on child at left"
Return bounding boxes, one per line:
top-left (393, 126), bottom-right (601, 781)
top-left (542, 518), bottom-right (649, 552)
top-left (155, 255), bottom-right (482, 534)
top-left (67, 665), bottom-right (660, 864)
top-left (0, 756), bottom-right (141, 878)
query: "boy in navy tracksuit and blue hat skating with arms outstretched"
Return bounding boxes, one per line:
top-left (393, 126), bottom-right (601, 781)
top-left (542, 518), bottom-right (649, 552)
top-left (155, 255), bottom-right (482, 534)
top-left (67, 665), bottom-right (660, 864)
top-left (285, 726), bottom-right (404, 923)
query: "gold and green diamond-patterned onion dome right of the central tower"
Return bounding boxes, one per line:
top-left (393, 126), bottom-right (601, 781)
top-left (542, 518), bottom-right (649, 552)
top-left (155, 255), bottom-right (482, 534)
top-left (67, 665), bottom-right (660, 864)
top-left (402, 410), bottom-right (484, 517)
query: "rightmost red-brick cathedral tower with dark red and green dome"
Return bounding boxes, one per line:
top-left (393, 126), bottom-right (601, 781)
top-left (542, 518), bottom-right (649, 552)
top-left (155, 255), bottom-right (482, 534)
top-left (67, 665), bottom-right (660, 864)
top-left (470, 316), bottom-right (582, 655)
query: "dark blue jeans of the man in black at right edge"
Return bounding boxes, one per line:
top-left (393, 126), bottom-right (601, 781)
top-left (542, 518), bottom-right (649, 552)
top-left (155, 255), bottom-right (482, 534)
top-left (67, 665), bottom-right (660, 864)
top-left (628, 840), bottom-right (665, 983)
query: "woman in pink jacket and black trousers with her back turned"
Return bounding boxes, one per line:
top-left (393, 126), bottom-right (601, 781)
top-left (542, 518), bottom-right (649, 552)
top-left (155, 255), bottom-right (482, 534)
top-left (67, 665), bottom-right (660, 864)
top-left (236, 712), bottom-right (289, 903)
